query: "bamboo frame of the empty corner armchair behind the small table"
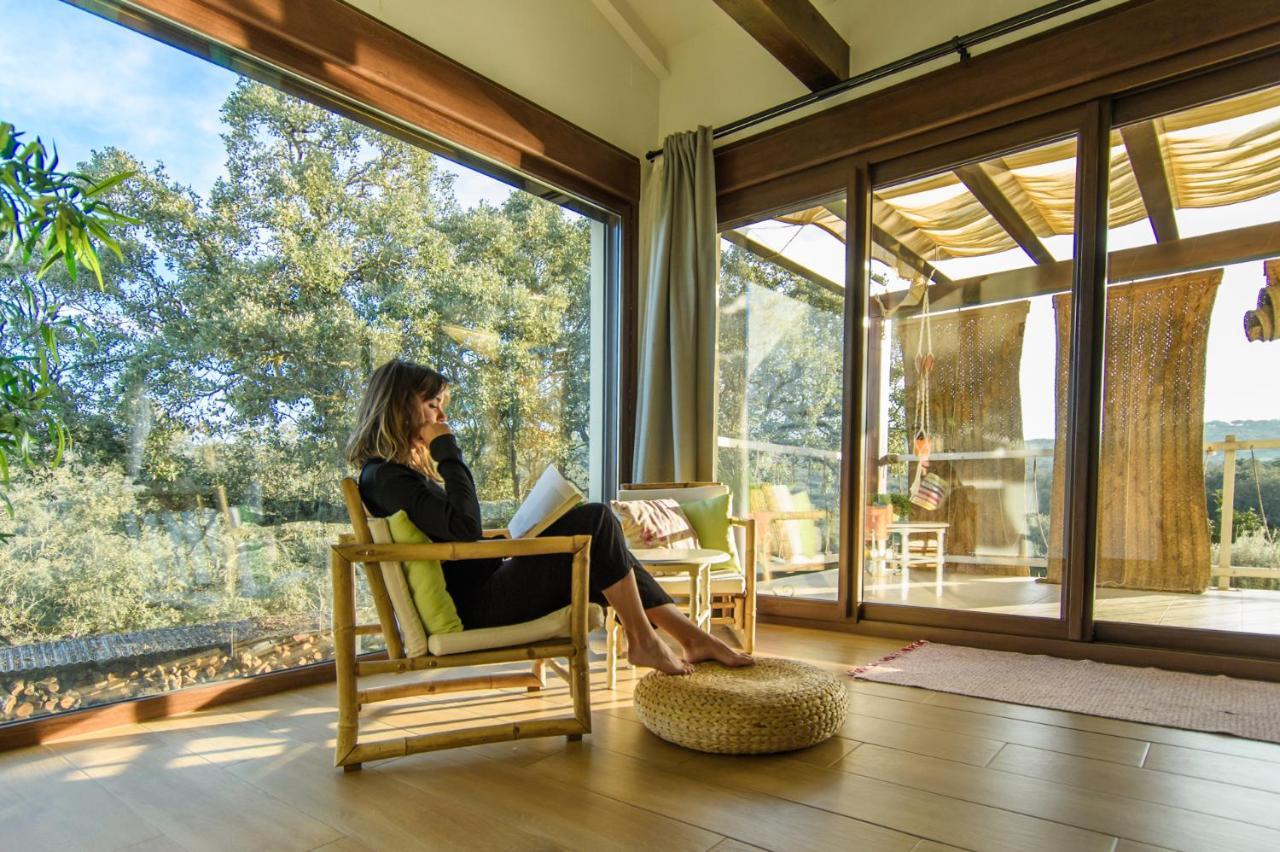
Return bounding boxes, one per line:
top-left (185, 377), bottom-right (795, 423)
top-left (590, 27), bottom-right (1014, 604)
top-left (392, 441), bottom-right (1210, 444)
top-left (605, 482), bottom-right (756, 665)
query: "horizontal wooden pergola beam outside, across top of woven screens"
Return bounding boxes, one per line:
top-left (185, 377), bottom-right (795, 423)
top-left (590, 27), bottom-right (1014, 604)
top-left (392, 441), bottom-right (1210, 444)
top-left (870, 223), bottom-right (1280, 319)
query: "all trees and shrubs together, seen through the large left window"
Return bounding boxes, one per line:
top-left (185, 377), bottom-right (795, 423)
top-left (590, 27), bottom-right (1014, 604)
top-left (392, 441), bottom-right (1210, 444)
top-left (0, 81), bottom-right (591, 643)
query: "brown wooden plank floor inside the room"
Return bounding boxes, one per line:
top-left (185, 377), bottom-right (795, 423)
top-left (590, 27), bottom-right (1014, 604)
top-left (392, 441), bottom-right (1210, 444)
top-left (0, 627), bottom-right (1280, 852)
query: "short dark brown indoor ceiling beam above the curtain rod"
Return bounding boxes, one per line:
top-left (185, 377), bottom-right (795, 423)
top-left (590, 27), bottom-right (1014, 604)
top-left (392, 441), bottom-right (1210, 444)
top-left (716, 0), bottom-right (849, 91)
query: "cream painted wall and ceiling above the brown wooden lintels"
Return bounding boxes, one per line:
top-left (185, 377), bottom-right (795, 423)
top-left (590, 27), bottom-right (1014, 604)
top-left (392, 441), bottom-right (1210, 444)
top-left (347, 0), bottom-right (1123, 155)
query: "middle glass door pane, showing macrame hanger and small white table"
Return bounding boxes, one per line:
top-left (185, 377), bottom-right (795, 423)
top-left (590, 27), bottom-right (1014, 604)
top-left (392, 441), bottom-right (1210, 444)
top-left (861, 134), bottom-right (1076, 619)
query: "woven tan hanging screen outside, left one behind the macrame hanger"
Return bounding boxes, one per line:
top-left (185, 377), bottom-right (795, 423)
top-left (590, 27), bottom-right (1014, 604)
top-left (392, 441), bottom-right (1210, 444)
top-left (899, 301), bottom-right (1030, 576)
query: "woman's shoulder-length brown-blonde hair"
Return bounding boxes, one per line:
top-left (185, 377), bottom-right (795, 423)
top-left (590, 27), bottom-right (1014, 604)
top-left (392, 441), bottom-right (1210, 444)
top-left (347, 359), bottom-right (449, 480)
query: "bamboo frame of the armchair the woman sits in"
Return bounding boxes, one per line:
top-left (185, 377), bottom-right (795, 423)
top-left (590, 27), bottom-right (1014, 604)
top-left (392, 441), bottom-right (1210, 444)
top-left (330, 477), bottom-right (591, 771)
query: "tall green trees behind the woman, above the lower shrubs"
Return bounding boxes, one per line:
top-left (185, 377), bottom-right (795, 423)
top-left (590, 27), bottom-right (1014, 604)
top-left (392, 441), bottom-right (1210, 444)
top-left (42, 81), bottom-right (590, 517)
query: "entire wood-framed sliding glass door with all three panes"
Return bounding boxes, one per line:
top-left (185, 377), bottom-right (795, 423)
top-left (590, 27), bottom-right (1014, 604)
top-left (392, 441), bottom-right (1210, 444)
top-left (719, 60), bottom-right (1280, 658)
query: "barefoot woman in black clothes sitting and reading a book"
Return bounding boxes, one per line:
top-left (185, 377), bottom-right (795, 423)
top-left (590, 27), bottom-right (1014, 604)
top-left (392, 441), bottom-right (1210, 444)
top-left (347, 361), bottom-right (751, 674)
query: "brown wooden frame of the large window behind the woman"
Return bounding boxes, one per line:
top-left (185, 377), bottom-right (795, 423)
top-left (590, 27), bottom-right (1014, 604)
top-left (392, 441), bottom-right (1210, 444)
top-left (0, 0), bottom-right (629, 751)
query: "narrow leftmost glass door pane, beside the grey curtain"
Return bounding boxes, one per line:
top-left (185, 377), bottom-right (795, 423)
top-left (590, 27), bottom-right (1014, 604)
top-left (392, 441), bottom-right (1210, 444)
top-left (718, 192), bottom-right (845, 615)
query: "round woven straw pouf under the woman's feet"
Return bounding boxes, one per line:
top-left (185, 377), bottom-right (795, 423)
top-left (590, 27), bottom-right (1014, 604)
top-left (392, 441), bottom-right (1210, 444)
top-left (635, 656), bottom-right (849, 755)
